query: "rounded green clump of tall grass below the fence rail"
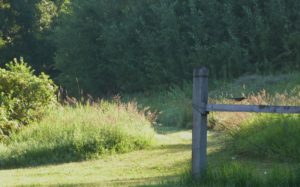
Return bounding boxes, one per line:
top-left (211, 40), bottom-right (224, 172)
top-left (229, 115), bottom-right (300, 162)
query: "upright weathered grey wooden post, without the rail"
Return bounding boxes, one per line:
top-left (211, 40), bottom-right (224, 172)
top-left (192, 68), bottom-right (209, 178)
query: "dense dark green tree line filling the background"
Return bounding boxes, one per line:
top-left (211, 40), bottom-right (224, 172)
top-left (0, 0), bottom-right (300, 95)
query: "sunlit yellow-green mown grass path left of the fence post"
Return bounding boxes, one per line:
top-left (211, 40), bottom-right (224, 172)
top-left (0, 130), bottom-right (225, 186)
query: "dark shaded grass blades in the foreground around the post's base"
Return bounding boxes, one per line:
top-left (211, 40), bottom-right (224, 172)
top-left (155, 162), bottom-right (300, 187)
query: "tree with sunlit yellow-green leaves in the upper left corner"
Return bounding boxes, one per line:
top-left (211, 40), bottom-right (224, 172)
top-left (0, 0), bottom-right (67, 72)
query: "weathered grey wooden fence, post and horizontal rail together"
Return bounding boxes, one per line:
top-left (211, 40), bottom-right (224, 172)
top-left (192, 68), bottom-right (300, 178)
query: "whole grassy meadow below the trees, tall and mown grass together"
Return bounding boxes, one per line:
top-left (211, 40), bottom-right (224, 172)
top-left (0, 73), bottom-right (300, 186)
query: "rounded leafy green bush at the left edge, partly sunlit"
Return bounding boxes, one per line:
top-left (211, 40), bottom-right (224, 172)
top-left (0, 59), bottom-right (56, 136)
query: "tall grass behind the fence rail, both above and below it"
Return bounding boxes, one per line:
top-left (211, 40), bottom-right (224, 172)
top-left (218, 74), bottom-right (300, 162)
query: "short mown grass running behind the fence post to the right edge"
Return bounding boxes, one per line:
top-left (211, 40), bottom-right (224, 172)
top-left (0, 128), bottom-right (300, 186)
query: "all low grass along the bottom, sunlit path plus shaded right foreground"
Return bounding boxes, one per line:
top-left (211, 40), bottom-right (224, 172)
top-left (0, 128), bottom-right (300, 187)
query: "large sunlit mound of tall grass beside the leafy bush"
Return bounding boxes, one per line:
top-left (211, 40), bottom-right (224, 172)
top-left (0, 101), bottom-right (154, 168)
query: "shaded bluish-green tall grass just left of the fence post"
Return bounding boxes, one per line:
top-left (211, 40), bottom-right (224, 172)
top-left (123, 83), bottom-right (192, 127)
